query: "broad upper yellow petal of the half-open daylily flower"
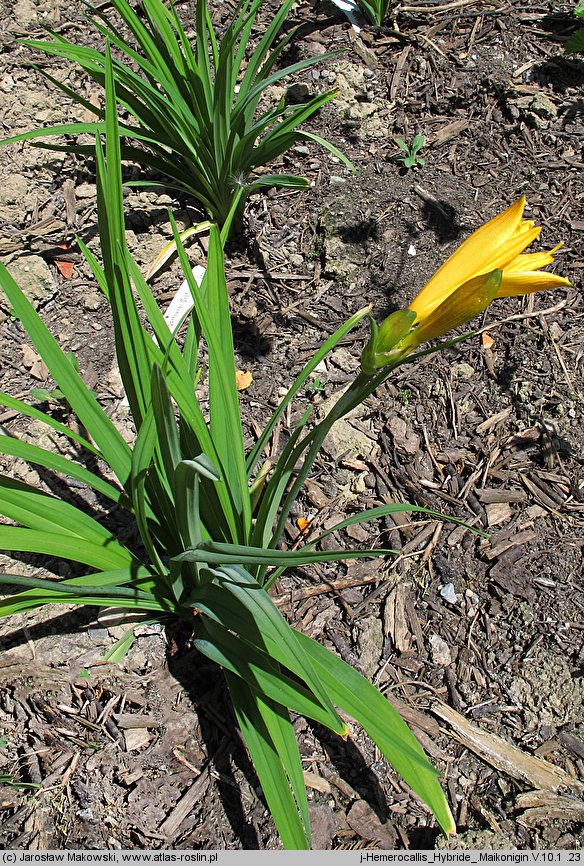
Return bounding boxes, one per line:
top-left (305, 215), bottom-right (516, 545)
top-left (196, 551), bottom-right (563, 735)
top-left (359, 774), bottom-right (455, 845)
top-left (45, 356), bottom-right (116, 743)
top-left (410, 198), bottom-right (540, 318)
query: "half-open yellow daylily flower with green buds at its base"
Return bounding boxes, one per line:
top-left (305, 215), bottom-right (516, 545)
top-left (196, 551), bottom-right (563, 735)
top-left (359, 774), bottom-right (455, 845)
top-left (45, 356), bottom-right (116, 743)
top-left (361, 197), bottom-right (571, 376)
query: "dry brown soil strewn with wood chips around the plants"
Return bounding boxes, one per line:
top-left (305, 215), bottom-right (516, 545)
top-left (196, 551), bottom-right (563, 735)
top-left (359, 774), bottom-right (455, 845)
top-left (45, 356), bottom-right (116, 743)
top-left (0, 0), bottom-right (584, 849)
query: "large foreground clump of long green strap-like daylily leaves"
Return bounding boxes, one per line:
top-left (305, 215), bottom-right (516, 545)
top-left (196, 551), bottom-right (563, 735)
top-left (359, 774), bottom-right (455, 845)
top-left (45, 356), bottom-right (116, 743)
top-left (0, 56), bottom-right (454, 849)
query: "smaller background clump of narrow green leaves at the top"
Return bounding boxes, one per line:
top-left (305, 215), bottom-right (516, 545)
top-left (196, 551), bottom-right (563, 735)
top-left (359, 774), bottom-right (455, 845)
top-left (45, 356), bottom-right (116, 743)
top-left (6, 0), bottom-right (352, 225)
